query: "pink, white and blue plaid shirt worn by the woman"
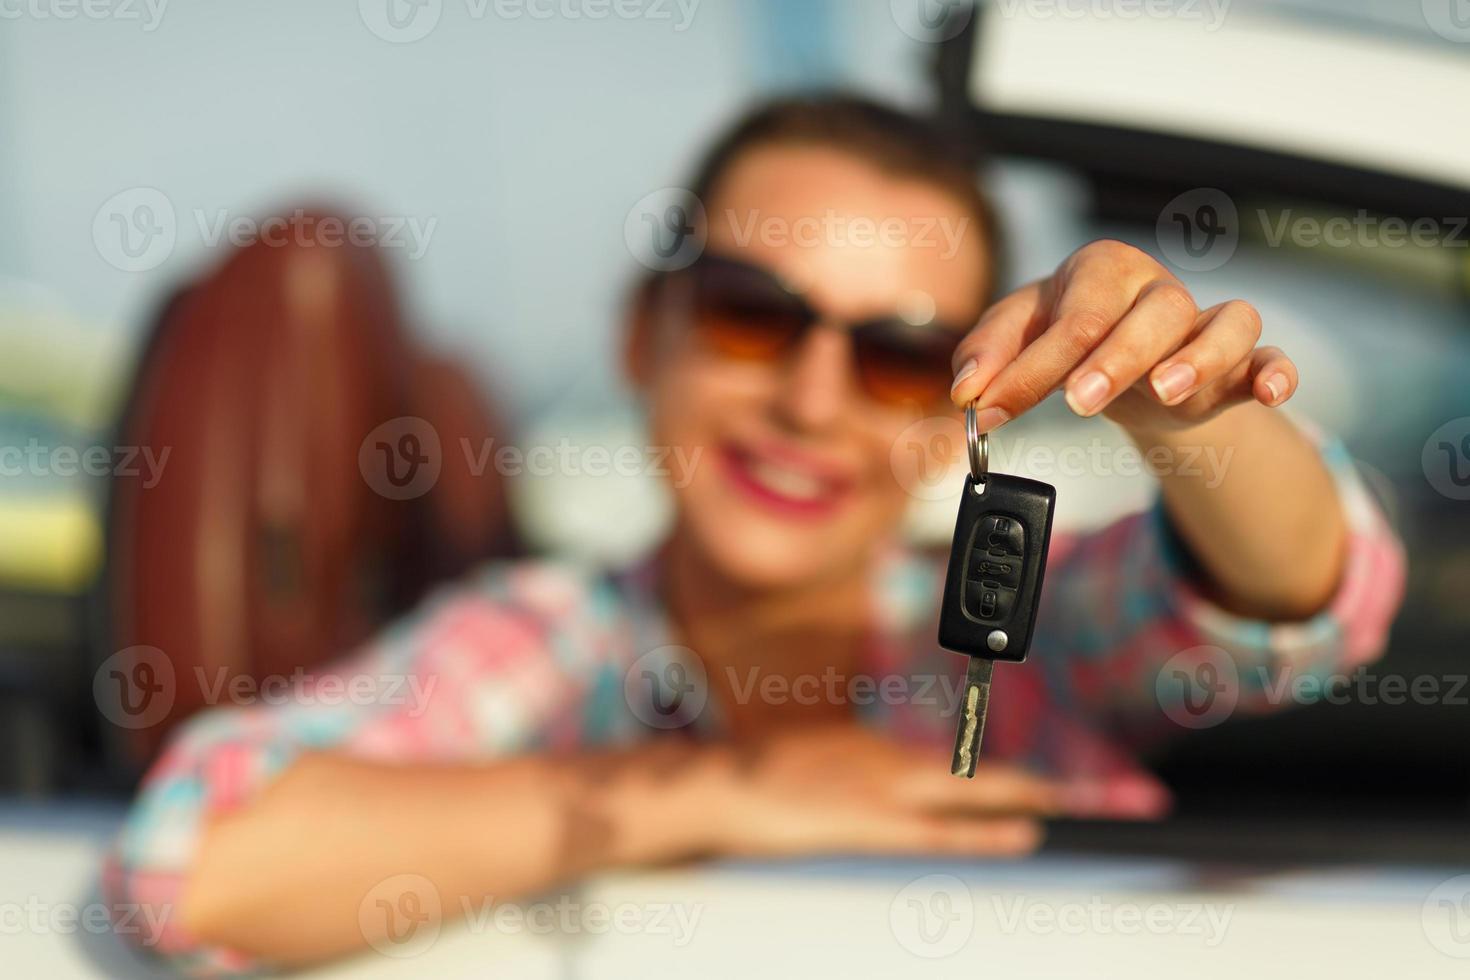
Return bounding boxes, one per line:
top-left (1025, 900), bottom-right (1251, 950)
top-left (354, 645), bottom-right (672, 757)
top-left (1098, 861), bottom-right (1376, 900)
top-left (104, 442), bottom-right (1405, 976)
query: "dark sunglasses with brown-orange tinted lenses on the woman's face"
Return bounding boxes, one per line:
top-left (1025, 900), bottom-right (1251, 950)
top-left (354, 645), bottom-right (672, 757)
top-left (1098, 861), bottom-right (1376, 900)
top-left (658, 253), bottom-right (964, 404)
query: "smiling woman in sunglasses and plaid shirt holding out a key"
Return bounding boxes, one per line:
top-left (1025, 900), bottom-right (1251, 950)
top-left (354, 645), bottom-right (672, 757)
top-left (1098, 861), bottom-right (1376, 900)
top-left (113, 98), bottom-right (1402, 968)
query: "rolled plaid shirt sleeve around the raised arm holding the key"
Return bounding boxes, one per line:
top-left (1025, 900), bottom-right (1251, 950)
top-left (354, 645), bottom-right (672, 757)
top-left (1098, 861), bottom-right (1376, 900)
top-left (1044, 426), bottom-right (1405, 730)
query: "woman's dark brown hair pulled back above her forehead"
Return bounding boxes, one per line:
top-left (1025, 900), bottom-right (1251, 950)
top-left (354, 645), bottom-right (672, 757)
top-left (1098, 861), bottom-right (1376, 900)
top-left (689, 94), bottom-right (1003, 306)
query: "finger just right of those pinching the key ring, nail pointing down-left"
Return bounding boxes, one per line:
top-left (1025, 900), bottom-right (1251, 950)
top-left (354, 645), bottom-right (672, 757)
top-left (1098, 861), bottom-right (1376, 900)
top-left (1066, 279), bottom-right (1198, 417)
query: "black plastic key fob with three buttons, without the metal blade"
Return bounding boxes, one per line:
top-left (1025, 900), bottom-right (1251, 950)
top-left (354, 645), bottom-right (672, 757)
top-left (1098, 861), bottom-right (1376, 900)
top-left (939, 473), bottom-right (1057, 663)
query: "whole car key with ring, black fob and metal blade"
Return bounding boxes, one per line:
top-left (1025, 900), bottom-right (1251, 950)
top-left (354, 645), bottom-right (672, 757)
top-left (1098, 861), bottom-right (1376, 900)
top-left (939, 406), bottom-right (1057, 779)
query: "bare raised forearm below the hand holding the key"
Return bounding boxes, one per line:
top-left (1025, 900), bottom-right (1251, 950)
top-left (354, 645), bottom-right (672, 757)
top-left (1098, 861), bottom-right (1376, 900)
top-left (1129, 403), bottom-right (1347, 620)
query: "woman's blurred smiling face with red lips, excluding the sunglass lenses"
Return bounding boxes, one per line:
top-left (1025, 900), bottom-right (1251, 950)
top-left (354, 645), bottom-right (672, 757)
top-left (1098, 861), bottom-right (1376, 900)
top-left (634, 144), bottom-right (989, 589)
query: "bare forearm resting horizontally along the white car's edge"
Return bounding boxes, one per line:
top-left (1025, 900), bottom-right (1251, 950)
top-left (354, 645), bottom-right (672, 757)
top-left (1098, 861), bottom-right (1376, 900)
top-left (181, 743), bottom-right (726, 965)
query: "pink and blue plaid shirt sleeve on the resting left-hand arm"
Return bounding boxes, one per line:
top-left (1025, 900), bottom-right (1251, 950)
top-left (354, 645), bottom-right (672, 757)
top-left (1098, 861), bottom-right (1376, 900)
top-left (103, 566), bottom-right (610, 976)
